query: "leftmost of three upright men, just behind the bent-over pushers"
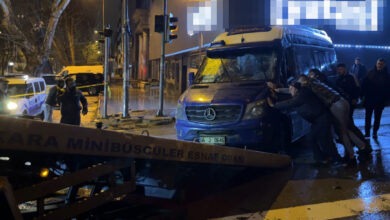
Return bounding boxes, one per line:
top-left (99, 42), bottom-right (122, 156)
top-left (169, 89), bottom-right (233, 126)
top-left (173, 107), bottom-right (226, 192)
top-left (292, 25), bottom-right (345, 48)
top-left (336, 63), bottom-right (359, 120)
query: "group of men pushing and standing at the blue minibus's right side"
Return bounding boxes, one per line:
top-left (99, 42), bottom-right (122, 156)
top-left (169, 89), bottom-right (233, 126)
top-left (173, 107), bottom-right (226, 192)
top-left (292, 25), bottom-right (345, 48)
top-left (267, 58), bottom-right (390, 165)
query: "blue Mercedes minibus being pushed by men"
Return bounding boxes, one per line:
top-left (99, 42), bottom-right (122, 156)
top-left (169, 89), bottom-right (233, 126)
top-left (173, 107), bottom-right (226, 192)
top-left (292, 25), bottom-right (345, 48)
top-left (176, 27), bottom-right (337, 150)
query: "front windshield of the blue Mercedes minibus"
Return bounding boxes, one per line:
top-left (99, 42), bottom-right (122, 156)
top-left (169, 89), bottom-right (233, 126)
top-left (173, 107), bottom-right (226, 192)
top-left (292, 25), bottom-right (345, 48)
top-left (194, 49), bottom-right (276, 84)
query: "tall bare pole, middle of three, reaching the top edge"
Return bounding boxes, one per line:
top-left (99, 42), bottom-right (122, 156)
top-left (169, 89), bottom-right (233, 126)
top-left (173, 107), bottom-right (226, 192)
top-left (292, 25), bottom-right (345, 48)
top-left (122, 0), bottom-right (130, 118)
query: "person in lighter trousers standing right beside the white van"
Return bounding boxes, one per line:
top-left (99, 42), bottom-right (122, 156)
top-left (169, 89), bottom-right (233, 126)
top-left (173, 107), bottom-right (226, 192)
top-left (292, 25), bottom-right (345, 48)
top-left (43, 79), bottom-right (65, 122)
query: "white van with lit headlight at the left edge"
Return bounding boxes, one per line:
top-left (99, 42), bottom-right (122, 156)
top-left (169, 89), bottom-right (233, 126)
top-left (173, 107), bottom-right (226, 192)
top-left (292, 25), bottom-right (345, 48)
top-left (7, 75), bottom-right (47, 118)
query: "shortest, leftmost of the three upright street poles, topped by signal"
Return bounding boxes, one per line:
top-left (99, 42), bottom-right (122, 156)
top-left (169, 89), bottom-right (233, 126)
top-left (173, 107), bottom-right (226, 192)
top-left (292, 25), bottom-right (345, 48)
top-left (103, 24), bottom-right (112, 118)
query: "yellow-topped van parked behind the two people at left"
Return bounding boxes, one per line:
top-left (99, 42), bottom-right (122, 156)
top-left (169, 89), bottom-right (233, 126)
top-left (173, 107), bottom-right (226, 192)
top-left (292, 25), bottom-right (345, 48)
top-left (57, 65), bottom-right (104, 96)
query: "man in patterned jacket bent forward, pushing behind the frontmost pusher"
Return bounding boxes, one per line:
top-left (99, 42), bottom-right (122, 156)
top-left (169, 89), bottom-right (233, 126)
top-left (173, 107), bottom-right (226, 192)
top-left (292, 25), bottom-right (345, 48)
top-left (297, 75), bottom-right (372, 163)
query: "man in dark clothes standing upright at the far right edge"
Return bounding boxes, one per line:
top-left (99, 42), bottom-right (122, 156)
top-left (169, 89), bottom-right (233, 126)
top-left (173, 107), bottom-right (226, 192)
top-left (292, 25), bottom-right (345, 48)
top-left (362, 58), bottom-right (390, 139)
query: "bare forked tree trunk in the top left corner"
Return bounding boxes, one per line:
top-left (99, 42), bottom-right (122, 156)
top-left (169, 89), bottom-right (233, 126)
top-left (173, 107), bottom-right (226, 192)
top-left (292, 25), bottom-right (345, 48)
top-left (0, 0), bottom-right (71, 75)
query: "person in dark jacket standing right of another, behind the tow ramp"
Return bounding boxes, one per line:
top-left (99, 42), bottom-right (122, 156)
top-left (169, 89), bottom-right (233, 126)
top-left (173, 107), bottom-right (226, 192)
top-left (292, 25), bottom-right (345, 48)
top-left (58, 77), bottom-right (88, 125)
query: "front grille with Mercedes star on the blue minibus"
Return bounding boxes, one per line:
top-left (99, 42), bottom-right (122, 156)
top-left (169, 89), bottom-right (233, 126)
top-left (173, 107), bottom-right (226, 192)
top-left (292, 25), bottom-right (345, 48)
top-left (186, 105), bottom-right (241, 124)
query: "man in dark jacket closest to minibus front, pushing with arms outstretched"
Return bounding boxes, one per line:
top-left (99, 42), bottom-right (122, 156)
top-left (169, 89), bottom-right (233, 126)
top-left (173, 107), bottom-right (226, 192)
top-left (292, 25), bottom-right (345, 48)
top-left (273, 82), bottom-right (339, 162)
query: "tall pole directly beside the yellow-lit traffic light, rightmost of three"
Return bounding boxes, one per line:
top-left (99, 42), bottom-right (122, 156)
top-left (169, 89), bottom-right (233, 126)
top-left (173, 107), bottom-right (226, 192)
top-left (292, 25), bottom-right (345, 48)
top-left (157, 0), bottom-right (168, 117)
